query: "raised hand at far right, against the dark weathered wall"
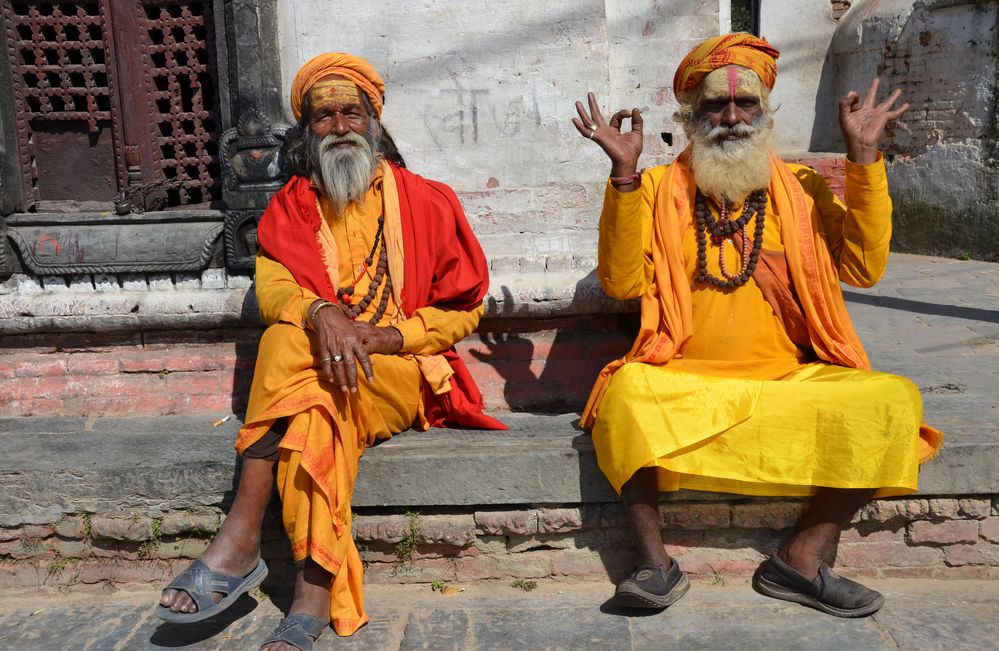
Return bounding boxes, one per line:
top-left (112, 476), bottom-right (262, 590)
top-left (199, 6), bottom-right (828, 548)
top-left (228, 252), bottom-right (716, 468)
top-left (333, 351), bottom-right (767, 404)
top-left (839, 77), bottom-right (909, 165)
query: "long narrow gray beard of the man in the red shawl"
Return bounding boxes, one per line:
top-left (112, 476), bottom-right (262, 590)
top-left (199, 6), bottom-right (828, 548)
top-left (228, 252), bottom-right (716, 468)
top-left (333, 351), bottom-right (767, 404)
top-left (309, 132), bottom-right (378, 214)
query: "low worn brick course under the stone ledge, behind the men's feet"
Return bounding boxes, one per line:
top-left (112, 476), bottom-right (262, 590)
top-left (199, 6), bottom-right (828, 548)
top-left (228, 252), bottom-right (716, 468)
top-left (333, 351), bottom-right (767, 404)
top-left (0, 494), bottom-right (999, 589)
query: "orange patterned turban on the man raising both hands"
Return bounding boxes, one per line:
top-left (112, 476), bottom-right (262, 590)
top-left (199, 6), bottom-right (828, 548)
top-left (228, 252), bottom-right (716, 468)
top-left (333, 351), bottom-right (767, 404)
top-left (673, 33), bottom-right (780, 101)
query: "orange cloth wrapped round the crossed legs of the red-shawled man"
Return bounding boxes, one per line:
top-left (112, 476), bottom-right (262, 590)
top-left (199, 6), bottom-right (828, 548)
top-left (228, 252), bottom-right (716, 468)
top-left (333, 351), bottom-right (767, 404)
top-left (236, 323), bottom-right (421, 635)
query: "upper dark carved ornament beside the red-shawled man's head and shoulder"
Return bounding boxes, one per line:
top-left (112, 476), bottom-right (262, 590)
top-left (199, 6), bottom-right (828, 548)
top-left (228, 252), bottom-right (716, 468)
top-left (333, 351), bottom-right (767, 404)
top-left (219, 108), bottom-right (290, 210)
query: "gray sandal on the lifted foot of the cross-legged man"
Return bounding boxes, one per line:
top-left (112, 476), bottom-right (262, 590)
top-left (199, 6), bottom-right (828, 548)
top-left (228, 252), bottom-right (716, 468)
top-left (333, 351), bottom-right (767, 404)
top-left (156, 558), bottom-right (267, 624)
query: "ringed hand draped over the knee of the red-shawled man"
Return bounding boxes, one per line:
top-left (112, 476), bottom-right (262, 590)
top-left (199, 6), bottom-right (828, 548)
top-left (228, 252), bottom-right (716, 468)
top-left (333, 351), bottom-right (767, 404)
top-left (310, 306), bottom-right (375, 393)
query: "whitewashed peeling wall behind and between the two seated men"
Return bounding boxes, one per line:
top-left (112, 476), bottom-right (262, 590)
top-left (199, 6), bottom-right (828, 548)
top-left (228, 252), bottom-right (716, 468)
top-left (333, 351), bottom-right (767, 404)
top-left (279, 0), bottom-right (728, 259)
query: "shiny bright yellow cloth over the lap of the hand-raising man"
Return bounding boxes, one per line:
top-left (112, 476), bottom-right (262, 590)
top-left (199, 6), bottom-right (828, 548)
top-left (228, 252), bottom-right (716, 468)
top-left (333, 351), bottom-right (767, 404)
top-left (593, 363), bottom-right (922, 497)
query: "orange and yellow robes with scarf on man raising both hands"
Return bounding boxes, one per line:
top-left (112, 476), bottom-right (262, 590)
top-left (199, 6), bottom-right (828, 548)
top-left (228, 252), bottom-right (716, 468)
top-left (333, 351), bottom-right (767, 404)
top-left (583, 155), bottom-right (941, 495)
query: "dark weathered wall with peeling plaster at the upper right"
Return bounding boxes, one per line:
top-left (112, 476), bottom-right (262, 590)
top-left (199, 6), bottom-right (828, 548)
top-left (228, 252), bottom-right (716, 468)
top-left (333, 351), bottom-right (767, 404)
top-left (833, 0), bottom-right (999, 260)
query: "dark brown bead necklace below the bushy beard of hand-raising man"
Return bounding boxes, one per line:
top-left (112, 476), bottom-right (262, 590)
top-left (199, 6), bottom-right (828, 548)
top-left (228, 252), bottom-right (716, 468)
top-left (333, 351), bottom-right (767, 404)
top-left (694, 190), bottom-right (767, 288)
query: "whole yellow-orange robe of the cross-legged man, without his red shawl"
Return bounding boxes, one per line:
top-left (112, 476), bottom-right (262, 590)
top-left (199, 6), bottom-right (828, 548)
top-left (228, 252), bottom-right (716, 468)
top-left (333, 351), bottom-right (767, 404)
top-left (236, 165), bottom-right (482, 635)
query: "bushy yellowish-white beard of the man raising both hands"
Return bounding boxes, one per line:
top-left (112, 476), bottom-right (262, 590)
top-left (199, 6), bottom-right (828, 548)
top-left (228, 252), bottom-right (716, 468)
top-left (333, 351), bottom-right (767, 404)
top-left (690, 114), bottom-right (773, 202)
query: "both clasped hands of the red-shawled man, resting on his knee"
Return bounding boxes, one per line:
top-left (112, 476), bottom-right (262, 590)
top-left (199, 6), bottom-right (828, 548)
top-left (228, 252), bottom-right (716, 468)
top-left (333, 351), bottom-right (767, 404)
top-left (313, 306), bottom-right (402, 393)
